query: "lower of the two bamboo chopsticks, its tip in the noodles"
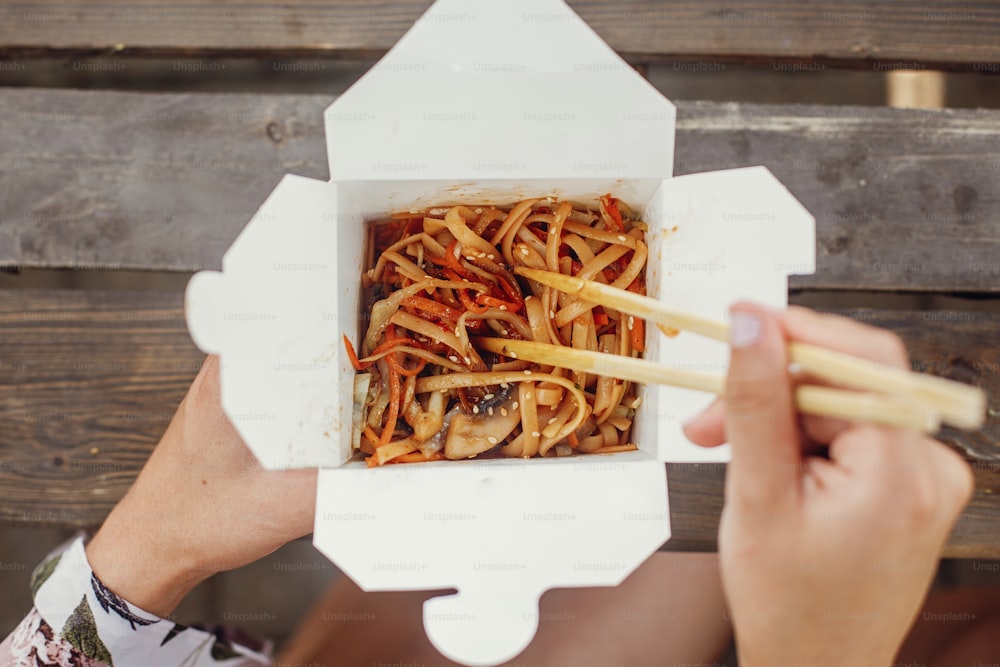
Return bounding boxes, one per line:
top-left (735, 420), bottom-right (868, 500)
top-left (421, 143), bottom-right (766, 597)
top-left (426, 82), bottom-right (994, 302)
top-left (476, 338), bottom-right (941, 433)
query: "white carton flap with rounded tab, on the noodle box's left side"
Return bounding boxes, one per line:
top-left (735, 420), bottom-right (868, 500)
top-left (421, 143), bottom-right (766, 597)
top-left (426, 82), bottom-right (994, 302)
top-left (185, 176), bottom-right (353, 468)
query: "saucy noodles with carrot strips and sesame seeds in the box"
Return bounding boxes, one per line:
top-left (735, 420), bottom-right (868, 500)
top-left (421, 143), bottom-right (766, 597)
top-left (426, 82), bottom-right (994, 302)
top-left (344, 195), bottom-right (648, 466)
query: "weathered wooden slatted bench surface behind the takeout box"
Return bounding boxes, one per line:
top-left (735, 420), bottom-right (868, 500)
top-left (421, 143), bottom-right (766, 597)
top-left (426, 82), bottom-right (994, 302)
top-left (0, 0), bottom-right (1000, 557)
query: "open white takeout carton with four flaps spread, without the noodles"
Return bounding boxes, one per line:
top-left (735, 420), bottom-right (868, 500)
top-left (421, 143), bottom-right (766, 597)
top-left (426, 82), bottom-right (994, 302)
top-left (186, 0), bottom-right (815, 665)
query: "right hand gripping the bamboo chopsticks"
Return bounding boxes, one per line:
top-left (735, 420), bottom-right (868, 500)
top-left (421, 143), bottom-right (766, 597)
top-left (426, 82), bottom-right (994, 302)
top-left (685, 303), bottom-right (973, 667)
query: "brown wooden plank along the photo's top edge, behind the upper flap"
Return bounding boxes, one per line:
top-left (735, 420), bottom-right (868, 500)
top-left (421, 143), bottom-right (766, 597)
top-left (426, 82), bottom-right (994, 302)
top-left (0, 0), bottom-right (1000, 68)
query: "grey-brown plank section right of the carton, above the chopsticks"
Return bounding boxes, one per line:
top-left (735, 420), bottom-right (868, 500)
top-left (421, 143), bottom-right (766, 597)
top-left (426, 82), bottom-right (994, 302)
top-left (675, 103), bottom-right (1000, 292)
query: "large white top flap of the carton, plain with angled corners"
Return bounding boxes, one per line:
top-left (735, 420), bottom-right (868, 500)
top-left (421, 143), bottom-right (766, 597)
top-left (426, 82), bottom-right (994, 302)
top-left (325, 0), bottom-right (675, 181)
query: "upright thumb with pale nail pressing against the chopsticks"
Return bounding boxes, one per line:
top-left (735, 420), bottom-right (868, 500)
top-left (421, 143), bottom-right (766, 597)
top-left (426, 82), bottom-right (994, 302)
top-left (726, 303), bottom-right (802, 503)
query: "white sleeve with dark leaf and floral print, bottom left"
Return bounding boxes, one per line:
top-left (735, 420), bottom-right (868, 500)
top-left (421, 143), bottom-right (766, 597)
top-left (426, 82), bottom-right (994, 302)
top-left (0, 536), bottom-right (270, 667)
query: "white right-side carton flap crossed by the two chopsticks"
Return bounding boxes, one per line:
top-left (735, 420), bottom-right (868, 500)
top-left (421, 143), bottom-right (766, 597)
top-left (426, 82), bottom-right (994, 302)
top-left (636, 167), bottom-right (816, 462)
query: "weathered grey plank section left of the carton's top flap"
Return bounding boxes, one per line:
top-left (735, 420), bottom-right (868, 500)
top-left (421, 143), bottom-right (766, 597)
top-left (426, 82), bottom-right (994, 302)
top-left (0, 89), bottom-right (332, 271)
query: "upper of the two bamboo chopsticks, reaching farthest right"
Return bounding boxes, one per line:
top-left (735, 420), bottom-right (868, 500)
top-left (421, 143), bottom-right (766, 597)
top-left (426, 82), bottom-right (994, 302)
top-left (515, 267), bottom-right (986, 428)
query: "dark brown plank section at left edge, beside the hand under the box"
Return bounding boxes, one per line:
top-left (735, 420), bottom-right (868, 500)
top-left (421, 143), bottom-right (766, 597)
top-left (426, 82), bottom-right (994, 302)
top-left (0, 290), bottom-right (202, 526)
